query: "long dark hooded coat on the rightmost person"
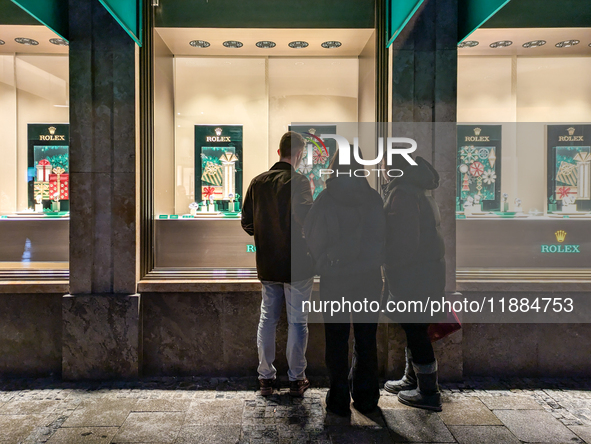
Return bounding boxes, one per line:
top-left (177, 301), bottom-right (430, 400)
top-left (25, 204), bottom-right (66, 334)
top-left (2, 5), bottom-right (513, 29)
top-left (384, 157), bottom-right (445, 297)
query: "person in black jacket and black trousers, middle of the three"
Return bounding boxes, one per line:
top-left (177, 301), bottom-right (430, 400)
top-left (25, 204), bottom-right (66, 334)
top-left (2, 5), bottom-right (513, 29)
top-left (304, 148), bottom-right (386, 416)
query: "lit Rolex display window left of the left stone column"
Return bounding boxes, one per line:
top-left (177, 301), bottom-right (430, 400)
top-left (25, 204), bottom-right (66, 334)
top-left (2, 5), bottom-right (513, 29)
top-left (0, 25), bottom-right (70, 270)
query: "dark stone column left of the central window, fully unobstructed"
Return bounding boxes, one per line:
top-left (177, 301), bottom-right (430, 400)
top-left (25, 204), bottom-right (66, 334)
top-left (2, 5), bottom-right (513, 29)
top-left (62, 0), bottom-right (141, 379)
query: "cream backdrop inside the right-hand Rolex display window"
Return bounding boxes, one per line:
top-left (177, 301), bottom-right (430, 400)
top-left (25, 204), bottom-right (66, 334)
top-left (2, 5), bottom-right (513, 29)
top-left (458, 56), bottom-right (591, 213)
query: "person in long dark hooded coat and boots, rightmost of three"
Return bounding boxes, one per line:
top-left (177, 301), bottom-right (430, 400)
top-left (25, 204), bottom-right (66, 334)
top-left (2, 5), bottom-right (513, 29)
top-left (384, 157), bottom-right (445, 411)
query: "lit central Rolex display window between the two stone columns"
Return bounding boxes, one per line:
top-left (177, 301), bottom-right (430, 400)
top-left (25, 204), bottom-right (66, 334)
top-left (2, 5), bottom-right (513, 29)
top-left (154, 28), bottom-right (376, 277)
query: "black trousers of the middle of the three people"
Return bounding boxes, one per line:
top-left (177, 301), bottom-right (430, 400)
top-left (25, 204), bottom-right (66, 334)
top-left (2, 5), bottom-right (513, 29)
top-left (320, 269), bottom-right (382, 411)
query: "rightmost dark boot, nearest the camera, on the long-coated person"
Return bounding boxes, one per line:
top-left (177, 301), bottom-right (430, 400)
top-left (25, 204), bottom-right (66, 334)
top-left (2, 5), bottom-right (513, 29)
top-left (398, 361), bottom-right (441, 412)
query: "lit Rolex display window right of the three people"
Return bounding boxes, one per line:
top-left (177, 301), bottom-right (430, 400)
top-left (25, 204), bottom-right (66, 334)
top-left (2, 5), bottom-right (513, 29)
top-left (456, 28), bottom-right (591, 282)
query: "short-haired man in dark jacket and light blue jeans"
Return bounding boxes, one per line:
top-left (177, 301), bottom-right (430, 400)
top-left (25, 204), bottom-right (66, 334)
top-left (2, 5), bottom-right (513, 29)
top-left (242, 131), bottom-right (313, 396)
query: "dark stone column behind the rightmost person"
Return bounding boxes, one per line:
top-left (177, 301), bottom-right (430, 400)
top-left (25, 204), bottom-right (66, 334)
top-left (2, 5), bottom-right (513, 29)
top-left (388, 0), bottom-right (462, 380)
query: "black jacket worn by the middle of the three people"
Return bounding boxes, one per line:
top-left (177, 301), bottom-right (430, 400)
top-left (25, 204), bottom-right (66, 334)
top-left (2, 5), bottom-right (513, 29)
top-left (304, 176), bottom-right (386, 276)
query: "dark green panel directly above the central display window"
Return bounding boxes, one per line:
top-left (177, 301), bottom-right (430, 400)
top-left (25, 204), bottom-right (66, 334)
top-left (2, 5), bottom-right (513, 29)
top-left (156, 0), bottom-right (375, 28)
